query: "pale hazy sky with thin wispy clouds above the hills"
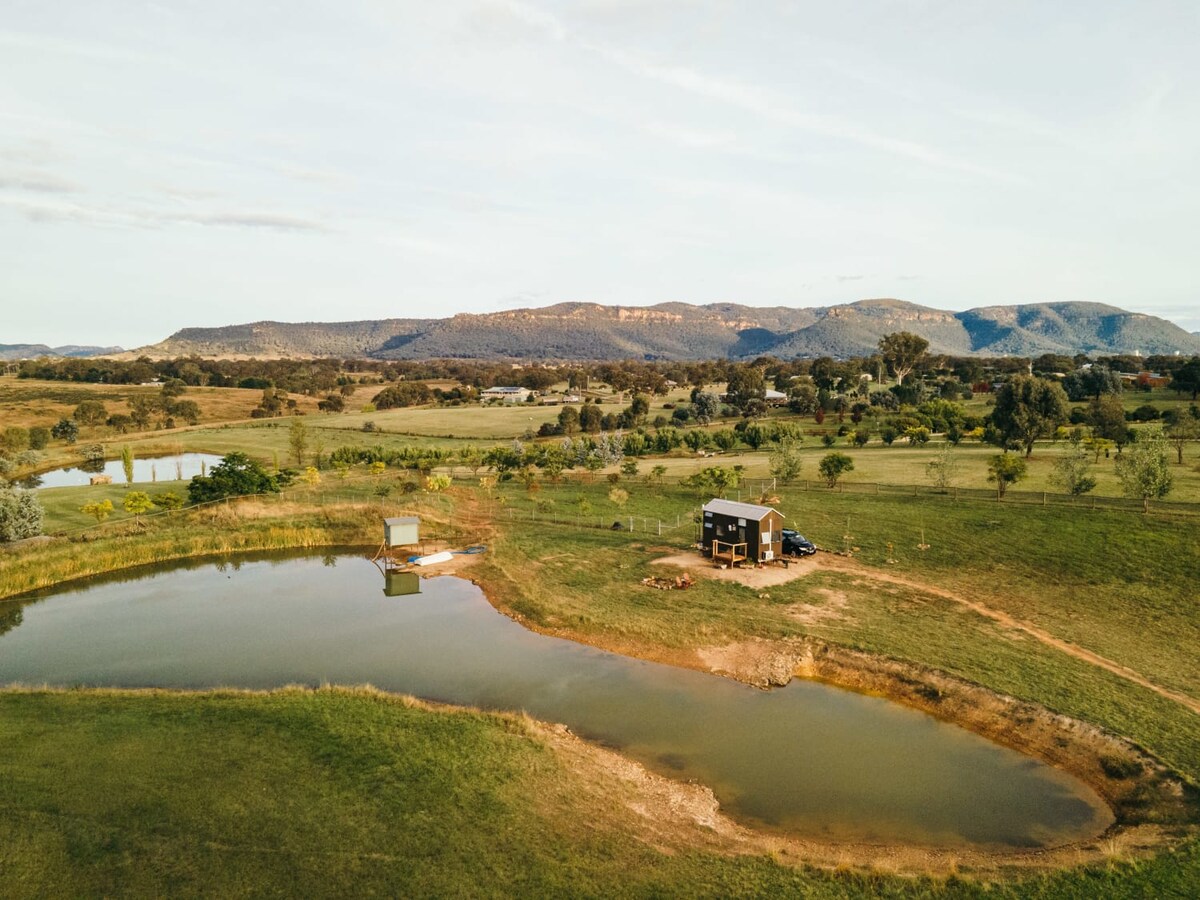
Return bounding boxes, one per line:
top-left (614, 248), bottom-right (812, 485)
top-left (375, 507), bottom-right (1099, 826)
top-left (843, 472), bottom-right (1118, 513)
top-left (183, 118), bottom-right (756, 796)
top-left (0, 0), bottom-right (1200, 347)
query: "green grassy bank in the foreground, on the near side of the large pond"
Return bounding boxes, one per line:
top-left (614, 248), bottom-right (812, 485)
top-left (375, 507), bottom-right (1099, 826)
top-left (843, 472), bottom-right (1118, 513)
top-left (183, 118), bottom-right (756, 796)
top-left (0, 690), bottom-right (1200, 898)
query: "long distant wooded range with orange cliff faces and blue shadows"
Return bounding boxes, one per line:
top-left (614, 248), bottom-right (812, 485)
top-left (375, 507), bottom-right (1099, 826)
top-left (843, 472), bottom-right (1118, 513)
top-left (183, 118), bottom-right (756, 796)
top-left (129, 300), bottom-right (1200, 360)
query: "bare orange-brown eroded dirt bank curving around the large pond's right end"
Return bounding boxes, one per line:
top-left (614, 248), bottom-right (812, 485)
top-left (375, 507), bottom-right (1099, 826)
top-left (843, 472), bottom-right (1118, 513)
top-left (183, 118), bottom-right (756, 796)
top-left (456, 549), bottom-right (1200, 874)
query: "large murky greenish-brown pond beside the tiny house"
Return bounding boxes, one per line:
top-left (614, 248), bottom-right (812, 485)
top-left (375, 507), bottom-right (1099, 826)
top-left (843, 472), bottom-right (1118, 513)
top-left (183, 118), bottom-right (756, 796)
top-left (0, 556), bottom-right (1111, 847)
